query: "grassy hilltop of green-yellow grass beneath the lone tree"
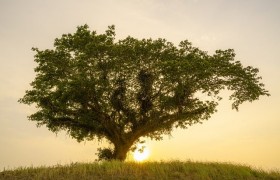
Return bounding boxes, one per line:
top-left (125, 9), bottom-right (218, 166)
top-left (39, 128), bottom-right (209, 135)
top-left (0, 161), bottom-right (280, 180)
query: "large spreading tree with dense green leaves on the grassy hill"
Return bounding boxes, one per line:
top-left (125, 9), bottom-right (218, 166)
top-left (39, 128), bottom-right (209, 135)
top-left (20, 25), bottom-right (269, 160)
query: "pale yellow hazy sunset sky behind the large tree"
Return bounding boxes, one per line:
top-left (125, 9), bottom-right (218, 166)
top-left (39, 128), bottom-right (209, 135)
top-left (0, 0), bottom-right (280, 171)
